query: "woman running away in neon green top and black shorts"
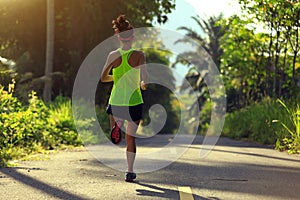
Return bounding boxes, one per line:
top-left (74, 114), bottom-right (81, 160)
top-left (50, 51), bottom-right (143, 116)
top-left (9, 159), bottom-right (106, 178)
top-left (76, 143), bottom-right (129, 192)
top-left (101, 15), bottom-right (148, 182)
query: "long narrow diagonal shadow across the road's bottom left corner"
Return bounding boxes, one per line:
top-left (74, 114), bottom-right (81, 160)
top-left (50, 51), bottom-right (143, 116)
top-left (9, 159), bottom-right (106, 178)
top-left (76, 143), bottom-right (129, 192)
top-left (0, 168), bottom-right (86, 200)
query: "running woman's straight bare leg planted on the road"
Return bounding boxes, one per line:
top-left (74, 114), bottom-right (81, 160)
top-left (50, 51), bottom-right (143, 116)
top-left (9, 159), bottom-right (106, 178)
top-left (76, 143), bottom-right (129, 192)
top-left (126, 121), bottom-right (140, 172)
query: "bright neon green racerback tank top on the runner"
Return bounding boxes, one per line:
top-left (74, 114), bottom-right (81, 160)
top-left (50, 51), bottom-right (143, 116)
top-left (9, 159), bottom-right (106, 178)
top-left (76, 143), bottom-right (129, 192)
top-left (109, 48), bottom-right (143, 106)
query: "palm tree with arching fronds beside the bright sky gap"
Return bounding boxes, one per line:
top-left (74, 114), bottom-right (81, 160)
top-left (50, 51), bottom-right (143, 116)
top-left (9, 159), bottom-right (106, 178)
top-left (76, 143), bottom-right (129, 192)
top-left (174, 14), bottom-right (226, 130)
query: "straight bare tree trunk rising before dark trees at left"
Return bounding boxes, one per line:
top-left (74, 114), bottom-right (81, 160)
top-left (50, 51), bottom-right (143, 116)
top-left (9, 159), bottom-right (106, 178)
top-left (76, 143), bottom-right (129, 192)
top-left (43, 0), bottom-right (54, 102)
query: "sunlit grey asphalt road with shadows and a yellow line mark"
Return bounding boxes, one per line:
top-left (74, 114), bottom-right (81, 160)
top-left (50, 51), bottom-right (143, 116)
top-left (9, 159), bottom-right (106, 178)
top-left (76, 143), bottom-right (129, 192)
top-left (0, 136), bottom-right (300, 200)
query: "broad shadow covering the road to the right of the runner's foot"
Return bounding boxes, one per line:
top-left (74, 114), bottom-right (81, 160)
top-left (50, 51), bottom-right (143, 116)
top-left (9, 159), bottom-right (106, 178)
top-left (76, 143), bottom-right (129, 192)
top-left (152, 158), bottom-right (300, 199)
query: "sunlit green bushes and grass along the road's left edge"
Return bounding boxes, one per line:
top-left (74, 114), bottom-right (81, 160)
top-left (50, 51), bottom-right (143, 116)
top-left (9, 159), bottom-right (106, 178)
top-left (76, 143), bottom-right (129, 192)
top-left (0, 85), bottom-right (110, 167)
